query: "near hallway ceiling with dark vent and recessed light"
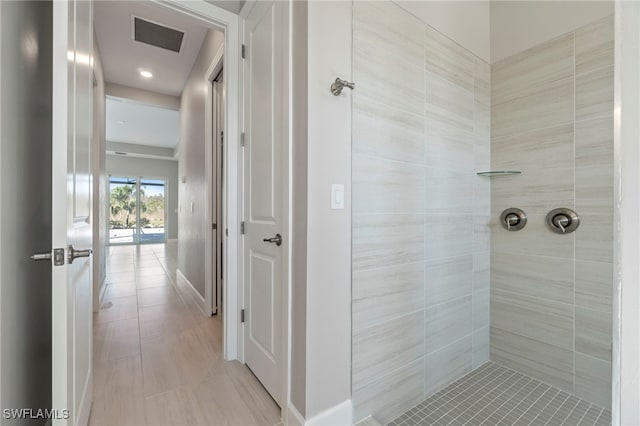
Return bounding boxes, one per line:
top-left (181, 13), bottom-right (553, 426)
top-left (94, 0), bottom-right (208, 96)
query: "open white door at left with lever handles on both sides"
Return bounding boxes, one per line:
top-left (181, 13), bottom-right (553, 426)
top-left (52, 0), bottom-right (93, 426)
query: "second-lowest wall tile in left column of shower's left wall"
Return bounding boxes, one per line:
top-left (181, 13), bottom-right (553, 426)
top-left (352, 310), bottom-right (424, 389)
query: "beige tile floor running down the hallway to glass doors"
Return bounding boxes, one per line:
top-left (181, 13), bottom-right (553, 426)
top-left (89, 242), bottom-right (280, 426)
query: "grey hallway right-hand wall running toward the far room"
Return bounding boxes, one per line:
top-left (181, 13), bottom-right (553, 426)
top-left (178, 30), bottom-right (224, 297)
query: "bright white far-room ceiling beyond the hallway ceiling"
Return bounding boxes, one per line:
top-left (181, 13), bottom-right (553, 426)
top-left (106, 96), bottom-right (180, 148)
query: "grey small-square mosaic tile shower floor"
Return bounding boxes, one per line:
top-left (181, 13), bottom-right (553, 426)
top-left (389, 362), bottom-right (611, 426)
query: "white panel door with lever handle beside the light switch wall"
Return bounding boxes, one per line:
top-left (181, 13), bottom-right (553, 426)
top-left (244, 1), bottom-right (288, 406)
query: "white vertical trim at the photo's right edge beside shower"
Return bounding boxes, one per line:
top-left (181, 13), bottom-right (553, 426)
top-left (611, 0), bottom-right (640, 425)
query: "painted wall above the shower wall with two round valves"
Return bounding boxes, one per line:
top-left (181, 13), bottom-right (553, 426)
top-left (491, 0), bottom-right (614, 62)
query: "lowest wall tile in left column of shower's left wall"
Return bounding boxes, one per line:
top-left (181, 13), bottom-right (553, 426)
top-left (352, 358), bottom-right (425, 424)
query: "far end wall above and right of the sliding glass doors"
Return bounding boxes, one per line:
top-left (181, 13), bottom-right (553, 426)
top-left (103, 155), bottom-right (179, 239)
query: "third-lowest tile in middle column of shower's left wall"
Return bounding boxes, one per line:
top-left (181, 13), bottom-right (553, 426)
top-left (423, 254), bottom-right (473, 307)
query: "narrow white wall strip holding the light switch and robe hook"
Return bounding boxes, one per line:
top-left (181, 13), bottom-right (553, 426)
top-left (304, 1), bottom-right (352, 419)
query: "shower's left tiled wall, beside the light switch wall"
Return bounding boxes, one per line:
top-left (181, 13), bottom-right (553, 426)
top-left (352, 2), bottom-right (490, 423)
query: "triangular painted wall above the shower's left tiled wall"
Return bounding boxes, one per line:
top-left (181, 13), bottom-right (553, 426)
top-left (393, 0), bottom-right (493, 62)
